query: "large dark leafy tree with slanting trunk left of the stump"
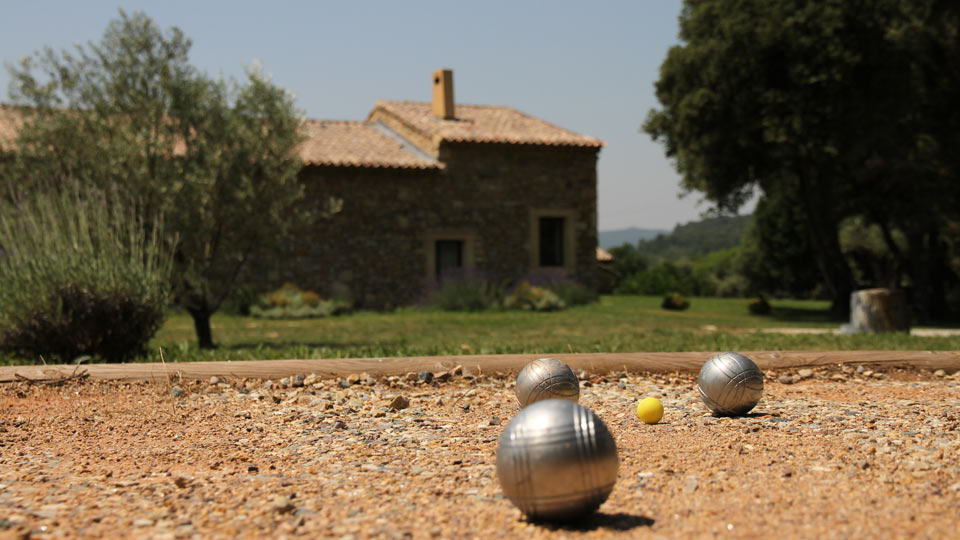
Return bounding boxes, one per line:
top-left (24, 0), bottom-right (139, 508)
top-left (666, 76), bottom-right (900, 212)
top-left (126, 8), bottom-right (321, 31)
top-left (644, 0), bottom-right (929, 313)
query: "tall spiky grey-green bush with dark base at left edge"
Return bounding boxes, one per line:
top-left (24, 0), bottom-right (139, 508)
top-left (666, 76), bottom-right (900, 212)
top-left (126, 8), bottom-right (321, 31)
top-left (0, 188), bottom-right (172, 362)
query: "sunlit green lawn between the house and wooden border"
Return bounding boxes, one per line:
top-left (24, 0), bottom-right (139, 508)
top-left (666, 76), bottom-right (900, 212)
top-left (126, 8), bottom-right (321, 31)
top-left (141, 296), bottom-right (960, 361)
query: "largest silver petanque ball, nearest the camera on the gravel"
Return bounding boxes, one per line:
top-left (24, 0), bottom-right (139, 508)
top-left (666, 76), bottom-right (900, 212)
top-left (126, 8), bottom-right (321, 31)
top-left (497, 399), bottom-right (620, 521)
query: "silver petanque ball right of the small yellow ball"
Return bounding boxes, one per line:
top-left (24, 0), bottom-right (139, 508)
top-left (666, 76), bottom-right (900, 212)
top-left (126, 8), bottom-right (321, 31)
top-left (697, 352), bottom-right (763, 416)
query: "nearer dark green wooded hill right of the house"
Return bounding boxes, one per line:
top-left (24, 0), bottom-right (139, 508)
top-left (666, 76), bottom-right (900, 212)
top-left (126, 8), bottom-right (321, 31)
top-left (637, 215), bottom-right (753, 260)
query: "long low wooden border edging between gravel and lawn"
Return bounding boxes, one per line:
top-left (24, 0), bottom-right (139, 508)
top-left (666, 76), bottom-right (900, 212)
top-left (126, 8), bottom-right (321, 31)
top-left (0, 351), bottom-right (960, 383)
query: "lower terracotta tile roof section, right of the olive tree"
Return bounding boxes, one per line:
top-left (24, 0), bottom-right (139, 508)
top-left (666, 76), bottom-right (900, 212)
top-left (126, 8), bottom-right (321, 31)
top-left (300, 120), bottom-right (443, 169)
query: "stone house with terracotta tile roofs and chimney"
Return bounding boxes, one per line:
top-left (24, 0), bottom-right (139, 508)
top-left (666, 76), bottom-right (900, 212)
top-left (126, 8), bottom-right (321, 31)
top-left (278, 70), bottom-right (603, 309)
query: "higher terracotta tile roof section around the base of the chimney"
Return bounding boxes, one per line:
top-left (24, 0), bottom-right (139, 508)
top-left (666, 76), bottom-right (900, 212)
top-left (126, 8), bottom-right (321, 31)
top-left (370, 100), bottom-right (603, 148)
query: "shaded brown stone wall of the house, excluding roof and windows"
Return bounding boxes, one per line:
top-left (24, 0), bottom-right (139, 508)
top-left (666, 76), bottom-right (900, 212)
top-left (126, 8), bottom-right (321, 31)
top-left (261, 143), bottom-right (597, 309)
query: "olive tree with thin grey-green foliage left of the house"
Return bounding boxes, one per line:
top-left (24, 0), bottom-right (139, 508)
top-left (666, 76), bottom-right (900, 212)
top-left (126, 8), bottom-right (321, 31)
top-left (3, 10), bottom-right (308, 348)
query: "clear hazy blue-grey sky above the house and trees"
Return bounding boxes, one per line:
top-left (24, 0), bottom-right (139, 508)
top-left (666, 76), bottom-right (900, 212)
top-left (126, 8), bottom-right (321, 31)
top-left (0, 0), bottom-right (752, 231)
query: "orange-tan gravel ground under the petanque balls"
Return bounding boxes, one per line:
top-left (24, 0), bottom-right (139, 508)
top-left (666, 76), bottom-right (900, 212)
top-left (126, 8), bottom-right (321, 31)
top-left (0, 366), bottom-right (960, 538)
